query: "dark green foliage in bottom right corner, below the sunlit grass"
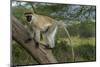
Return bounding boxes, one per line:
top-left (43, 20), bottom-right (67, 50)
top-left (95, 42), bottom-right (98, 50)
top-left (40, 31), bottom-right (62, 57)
top-left (75, 44), bottom-right (96, 61)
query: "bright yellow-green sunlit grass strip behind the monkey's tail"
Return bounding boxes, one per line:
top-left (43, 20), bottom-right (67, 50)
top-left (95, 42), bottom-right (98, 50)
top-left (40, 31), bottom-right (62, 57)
top-left (57, 36), bottom-right (95, 46)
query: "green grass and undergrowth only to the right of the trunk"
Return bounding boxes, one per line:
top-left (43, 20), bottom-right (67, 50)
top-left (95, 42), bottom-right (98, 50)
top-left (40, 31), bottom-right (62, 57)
top-left (53, 36), bottom-right (96, 62)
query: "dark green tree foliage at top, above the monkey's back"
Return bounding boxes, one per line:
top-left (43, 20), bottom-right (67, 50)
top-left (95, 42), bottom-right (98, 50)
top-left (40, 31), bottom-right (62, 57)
top-left (36, 4), bottom-right (67, 17)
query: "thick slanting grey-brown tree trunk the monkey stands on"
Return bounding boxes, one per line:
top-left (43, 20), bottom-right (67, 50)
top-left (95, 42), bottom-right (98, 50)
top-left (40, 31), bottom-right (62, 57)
top-left (11, 16), bottom-right (57, 64)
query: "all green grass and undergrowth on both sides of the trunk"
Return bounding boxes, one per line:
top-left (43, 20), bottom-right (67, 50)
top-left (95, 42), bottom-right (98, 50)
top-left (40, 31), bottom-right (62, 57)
top-left (12, 36), bottom-right (96, 65)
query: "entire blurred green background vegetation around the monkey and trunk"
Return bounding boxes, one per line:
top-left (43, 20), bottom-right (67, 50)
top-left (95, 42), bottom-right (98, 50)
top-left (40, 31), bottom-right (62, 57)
top-left (11, 1), bottom-right (96, 65)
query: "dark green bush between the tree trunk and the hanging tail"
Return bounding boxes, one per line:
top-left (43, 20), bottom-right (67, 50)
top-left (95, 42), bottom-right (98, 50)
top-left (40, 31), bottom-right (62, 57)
top-left (53, 41), bottom-right (73, 63)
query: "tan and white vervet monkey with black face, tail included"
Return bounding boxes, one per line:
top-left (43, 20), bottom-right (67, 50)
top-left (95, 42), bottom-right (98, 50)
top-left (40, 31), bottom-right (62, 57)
top-left (25, 12), bottom-right (74, 59)
